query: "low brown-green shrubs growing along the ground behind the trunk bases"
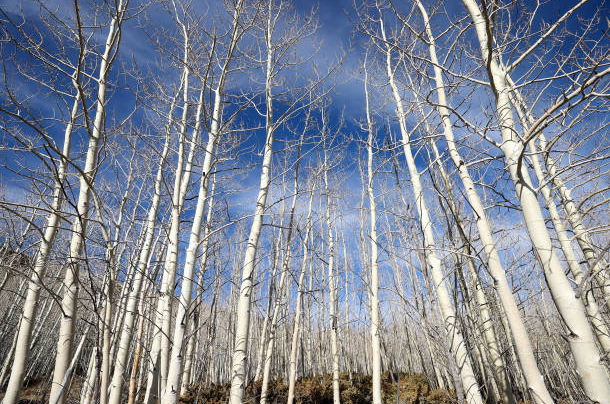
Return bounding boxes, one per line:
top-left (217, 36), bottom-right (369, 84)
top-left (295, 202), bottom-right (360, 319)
top-left (180, 372), bottom-right (455, 404)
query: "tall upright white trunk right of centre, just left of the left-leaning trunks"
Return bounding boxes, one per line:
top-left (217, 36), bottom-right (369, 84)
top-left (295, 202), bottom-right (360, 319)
top-left (364, 62), bottom-right (381, 404)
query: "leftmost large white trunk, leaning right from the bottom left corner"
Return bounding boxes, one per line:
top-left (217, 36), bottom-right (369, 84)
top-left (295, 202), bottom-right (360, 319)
top-left (0, 86), bottom-right (81, 404)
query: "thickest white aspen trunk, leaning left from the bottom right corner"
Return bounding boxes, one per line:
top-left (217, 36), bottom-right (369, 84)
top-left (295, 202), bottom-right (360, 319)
top-left (462, 0), bottom-right (610, 404)
